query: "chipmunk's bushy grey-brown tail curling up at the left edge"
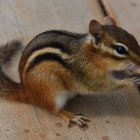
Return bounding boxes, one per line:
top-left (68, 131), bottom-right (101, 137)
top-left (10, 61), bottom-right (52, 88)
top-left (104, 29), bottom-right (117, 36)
top-left (0, 41), bottom-right (22, 100)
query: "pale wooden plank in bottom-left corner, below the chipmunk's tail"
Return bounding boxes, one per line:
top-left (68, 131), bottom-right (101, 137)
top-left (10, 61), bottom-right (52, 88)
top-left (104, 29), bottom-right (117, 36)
top-left (0, 99), bottom-right (44, 140)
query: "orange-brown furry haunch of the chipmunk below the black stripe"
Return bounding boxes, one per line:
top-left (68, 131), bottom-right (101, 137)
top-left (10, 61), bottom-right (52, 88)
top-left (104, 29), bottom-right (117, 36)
top-left (23, 62), bottom-right (72, 112)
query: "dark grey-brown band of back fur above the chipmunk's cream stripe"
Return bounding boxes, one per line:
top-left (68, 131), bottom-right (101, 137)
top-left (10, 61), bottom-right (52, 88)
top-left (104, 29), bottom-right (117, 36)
top-left (22, 30), bottom-right (86, 59)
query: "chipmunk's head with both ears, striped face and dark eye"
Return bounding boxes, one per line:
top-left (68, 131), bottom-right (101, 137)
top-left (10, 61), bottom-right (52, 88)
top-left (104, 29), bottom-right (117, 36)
top-left (89, 17), bottom-right (140, 87)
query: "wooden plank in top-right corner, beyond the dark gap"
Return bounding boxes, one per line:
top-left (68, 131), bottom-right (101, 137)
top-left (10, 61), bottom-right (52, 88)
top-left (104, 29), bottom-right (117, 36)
top-left (102, 0), bottom-right (140, 42)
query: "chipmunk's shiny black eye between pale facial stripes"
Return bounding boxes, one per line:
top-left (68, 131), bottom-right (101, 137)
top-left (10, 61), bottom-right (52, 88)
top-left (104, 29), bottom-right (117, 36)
top-left (113, 45), bottom-right (128, 55)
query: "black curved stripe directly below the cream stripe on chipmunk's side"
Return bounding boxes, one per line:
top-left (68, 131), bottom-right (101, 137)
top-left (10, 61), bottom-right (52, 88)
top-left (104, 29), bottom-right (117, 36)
top-left (26, 53), bottom-right (68, 72)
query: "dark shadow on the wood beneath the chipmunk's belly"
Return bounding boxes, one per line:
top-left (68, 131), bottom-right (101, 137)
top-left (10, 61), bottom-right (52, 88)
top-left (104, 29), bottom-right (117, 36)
top-left (66, 88), bottom-right (140, 118)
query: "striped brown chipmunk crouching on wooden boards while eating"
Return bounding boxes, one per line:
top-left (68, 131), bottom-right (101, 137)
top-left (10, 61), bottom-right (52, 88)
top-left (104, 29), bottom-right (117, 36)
top-left (0, 17), bottom-right (140, 129)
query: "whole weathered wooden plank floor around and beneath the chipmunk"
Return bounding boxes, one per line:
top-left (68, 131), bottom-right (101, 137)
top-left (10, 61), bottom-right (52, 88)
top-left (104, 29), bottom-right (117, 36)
top-left (0, 0), bottom-right (140, 140)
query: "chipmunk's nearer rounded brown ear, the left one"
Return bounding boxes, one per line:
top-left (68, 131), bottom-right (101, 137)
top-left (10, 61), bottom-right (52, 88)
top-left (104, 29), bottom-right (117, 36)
top-left (89, 20), bottom-right (103, 45)
